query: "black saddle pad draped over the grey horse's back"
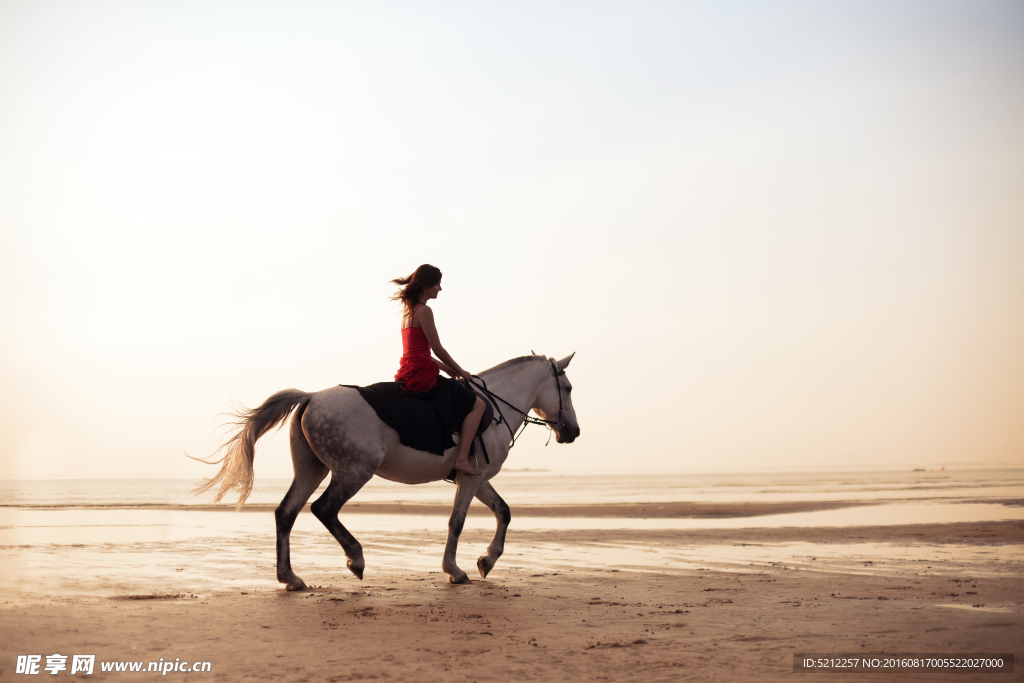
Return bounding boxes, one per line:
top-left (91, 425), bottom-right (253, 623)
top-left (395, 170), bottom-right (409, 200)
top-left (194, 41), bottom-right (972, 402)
top-left (340, 378), bottom-right (494, 456)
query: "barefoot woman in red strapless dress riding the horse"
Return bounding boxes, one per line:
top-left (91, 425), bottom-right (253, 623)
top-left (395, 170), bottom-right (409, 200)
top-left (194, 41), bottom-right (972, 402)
top-left (391, 263), bottom-right (484, 476)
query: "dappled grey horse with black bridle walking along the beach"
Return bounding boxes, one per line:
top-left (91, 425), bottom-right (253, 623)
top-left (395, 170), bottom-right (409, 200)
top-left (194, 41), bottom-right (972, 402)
top-left (195, 354), bottom-right (580, 591)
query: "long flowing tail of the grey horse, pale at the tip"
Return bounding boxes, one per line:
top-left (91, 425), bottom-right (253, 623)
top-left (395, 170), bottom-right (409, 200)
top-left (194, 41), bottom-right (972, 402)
top-left (185, 389), bottom-right (311, 510)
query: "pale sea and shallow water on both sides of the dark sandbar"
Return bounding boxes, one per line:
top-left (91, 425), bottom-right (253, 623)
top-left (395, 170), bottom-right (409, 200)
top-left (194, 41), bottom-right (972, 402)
top-left (0, 468), bottom-right (1024, 545)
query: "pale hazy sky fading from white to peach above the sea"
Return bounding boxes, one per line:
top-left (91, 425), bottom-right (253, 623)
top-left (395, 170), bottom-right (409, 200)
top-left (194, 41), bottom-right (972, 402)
top-left (0, 0), bottom-right (1024, 480)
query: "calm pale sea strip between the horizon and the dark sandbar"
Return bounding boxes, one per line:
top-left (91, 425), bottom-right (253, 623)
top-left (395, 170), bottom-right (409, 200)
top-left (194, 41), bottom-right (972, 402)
top-left (0, 468), bottom-right (1024, 508)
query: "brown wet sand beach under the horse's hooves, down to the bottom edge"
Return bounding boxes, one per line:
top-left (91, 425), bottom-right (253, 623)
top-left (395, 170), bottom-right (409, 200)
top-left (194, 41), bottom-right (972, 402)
top-left (0, 506), bottom-right (1024, 681)
